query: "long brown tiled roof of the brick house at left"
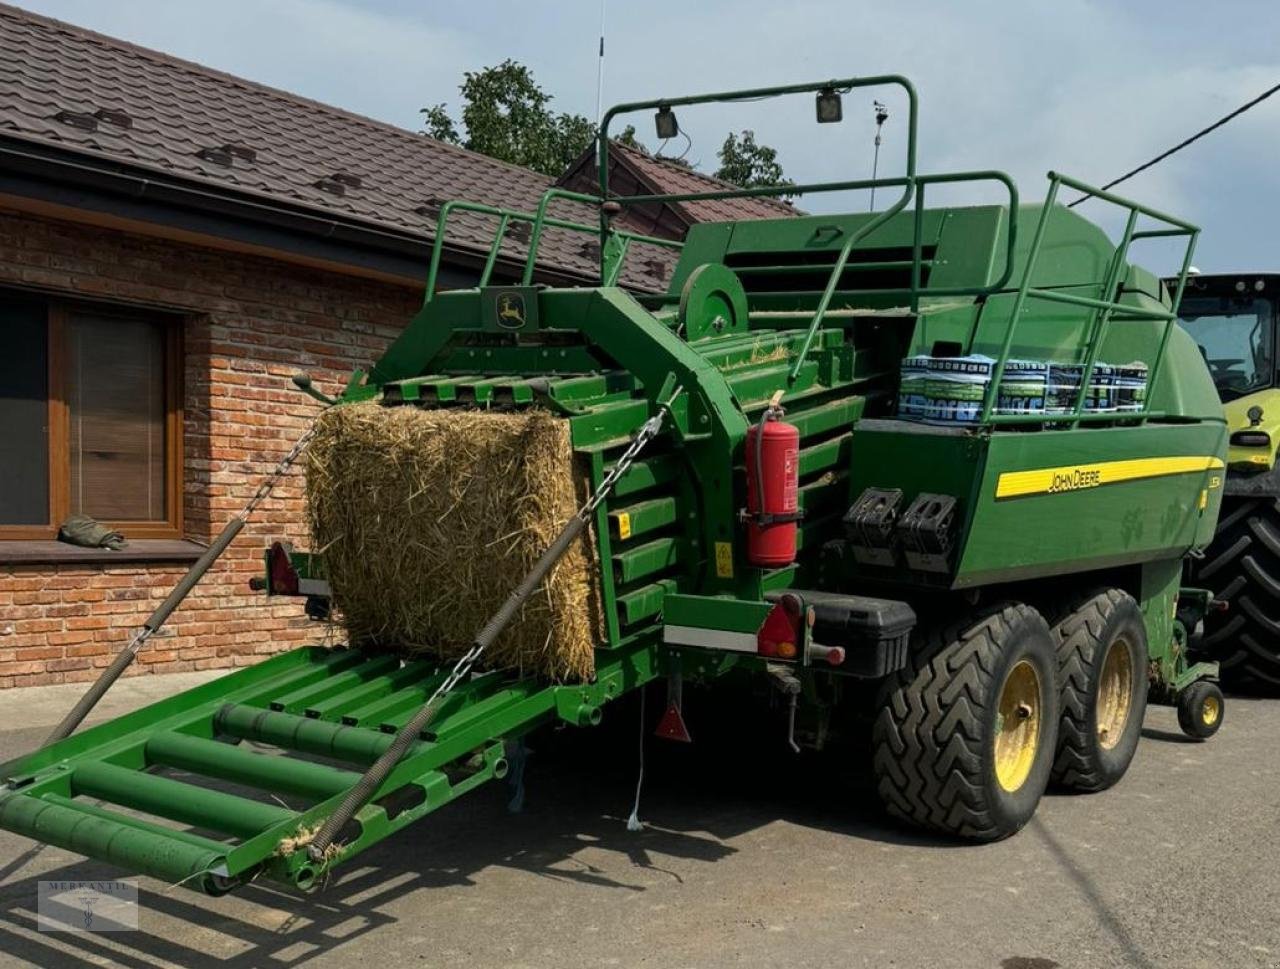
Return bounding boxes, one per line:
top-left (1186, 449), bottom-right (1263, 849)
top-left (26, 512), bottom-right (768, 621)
top-left (0, 4), bottom-right (675, 282)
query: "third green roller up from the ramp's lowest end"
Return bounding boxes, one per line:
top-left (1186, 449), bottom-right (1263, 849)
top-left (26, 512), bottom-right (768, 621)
top-left (146, 732), bottom-right (360, 801)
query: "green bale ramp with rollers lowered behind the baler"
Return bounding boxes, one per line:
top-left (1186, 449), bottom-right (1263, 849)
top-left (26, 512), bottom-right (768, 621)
top-left (0, 642), bottom-right (663, 893)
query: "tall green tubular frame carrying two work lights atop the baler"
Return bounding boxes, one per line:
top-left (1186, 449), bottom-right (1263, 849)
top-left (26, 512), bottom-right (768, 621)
top-left (596, 74), bottom-right (1018, 384)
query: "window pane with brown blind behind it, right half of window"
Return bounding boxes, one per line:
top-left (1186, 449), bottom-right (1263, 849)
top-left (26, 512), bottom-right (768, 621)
top-left (67, 314), bottom-right (166, 521)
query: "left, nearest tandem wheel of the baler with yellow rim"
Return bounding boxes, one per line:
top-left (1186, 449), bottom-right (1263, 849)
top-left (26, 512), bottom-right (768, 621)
top-left (873, 603), bottom-right (1059, 841)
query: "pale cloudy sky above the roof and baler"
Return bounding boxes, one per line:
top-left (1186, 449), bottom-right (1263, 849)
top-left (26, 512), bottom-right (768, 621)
top-left (12, 0), bottom-right (1280, 271)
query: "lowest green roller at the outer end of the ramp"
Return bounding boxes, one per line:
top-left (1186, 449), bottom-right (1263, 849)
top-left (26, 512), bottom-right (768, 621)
top-left (0, 795), bottom-right (229, 892)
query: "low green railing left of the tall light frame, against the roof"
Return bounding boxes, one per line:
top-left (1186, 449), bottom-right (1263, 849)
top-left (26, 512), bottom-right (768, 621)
top-left (422, 188), bottom-right (684, 303)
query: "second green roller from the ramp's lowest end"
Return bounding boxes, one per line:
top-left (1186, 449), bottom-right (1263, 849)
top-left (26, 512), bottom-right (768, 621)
top-left (72, 760), bottom-right (294, 838)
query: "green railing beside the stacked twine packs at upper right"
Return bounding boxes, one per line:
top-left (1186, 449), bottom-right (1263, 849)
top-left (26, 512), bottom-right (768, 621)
top-left (978, 172), bottom-right (1199, 428)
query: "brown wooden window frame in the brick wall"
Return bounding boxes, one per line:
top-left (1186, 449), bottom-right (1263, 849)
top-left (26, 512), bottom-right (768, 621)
top-left (0, 289), bottom-right (184, 541)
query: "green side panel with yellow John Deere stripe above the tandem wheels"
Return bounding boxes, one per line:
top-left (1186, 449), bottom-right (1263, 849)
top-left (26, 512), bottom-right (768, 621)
top-left (850, 421), bottom-right (1226, 588)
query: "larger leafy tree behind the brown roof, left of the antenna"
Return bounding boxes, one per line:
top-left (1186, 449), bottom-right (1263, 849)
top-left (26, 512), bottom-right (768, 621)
top-left (422, 59), bottom-right (596, 175)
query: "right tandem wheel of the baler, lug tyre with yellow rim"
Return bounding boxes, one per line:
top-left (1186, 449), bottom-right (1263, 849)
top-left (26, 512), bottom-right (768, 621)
top-left (1051, 589), bottom-right (1147, 791)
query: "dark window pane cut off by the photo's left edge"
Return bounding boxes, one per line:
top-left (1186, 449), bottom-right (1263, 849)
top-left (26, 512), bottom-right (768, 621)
top-left (0, 294), bottom-right (49, 525)
